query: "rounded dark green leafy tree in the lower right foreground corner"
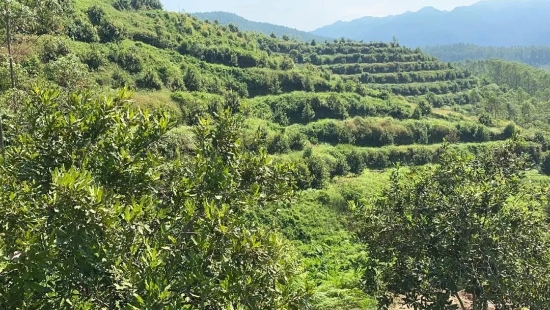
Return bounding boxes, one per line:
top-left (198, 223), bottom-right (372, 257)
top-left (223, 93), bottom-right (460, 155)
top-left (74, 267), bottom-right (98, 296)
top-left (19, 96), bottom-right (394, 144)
top-left (358, 142), bottom-right (550, 310)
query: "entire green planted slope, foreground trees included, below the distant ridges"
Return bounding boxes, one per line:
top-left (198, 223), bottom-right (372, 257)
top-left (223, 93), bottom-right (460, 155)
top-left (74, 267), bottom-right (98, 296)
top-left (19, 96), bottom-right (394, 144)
top-left (0, 0), bottom-right (550, 310)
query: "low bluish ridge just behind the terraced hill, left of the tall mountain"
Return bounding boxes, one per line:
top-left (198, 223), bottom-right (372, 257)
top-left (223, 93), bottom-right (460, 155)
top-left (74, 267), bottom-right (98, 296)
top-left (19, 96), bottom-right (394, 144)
top-left (191, 11), bottom-right (328, 41)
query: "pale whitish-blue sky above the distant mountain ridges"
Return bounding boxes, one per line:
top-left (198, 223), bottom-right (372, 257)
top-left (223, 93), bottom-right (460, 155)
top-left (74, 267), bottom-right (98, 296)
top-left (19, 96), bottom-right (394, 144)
top-left (161, 0), bottom-right (479, 30)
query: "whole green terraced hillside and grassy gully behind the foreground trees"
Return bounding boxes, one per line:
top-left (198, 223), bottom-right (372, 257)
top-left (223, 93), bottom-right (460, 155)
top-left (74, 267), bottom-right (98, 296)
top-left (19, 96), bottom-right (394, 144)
top-left (0, 0), bottom-right (550, 309)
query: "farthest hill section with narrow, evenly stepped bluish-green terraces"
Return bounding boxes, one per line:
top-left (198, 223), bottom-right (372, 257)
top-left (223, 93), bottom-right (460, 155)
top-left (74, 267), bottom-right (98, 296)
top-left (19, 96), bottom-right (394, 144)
top-left (258, 40), bottom-right (486, 111)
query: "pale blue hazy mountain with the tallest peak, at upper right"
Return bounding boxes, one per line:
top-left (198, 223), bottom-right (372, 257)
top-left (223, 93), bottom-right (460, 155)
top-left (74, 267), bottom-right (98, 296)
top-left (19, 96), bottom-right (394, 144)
top-left (312, 0), bottom-right (550, 47)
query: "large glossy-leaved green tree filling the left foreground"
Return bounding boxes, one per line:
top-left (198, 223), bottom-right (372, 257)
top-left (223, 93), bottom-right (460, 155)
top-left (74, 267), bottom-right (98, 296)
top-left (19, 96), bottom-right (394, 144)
top-left (0, 88), bottom-right (307, 309)
